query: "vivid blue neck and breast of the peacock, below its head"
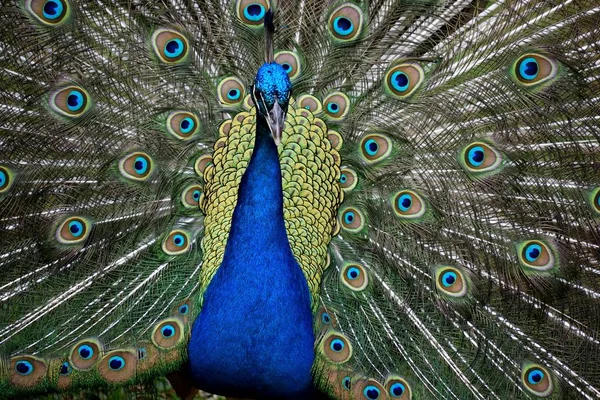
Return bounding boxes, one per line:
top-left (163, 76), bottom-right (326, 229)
top-left (188, 115), bottom-right (314, 398)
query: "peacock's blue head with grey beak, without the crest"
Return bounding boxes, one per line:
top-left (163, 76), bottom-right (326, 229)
top-left (252, 63), bottom-right (292, 145)
